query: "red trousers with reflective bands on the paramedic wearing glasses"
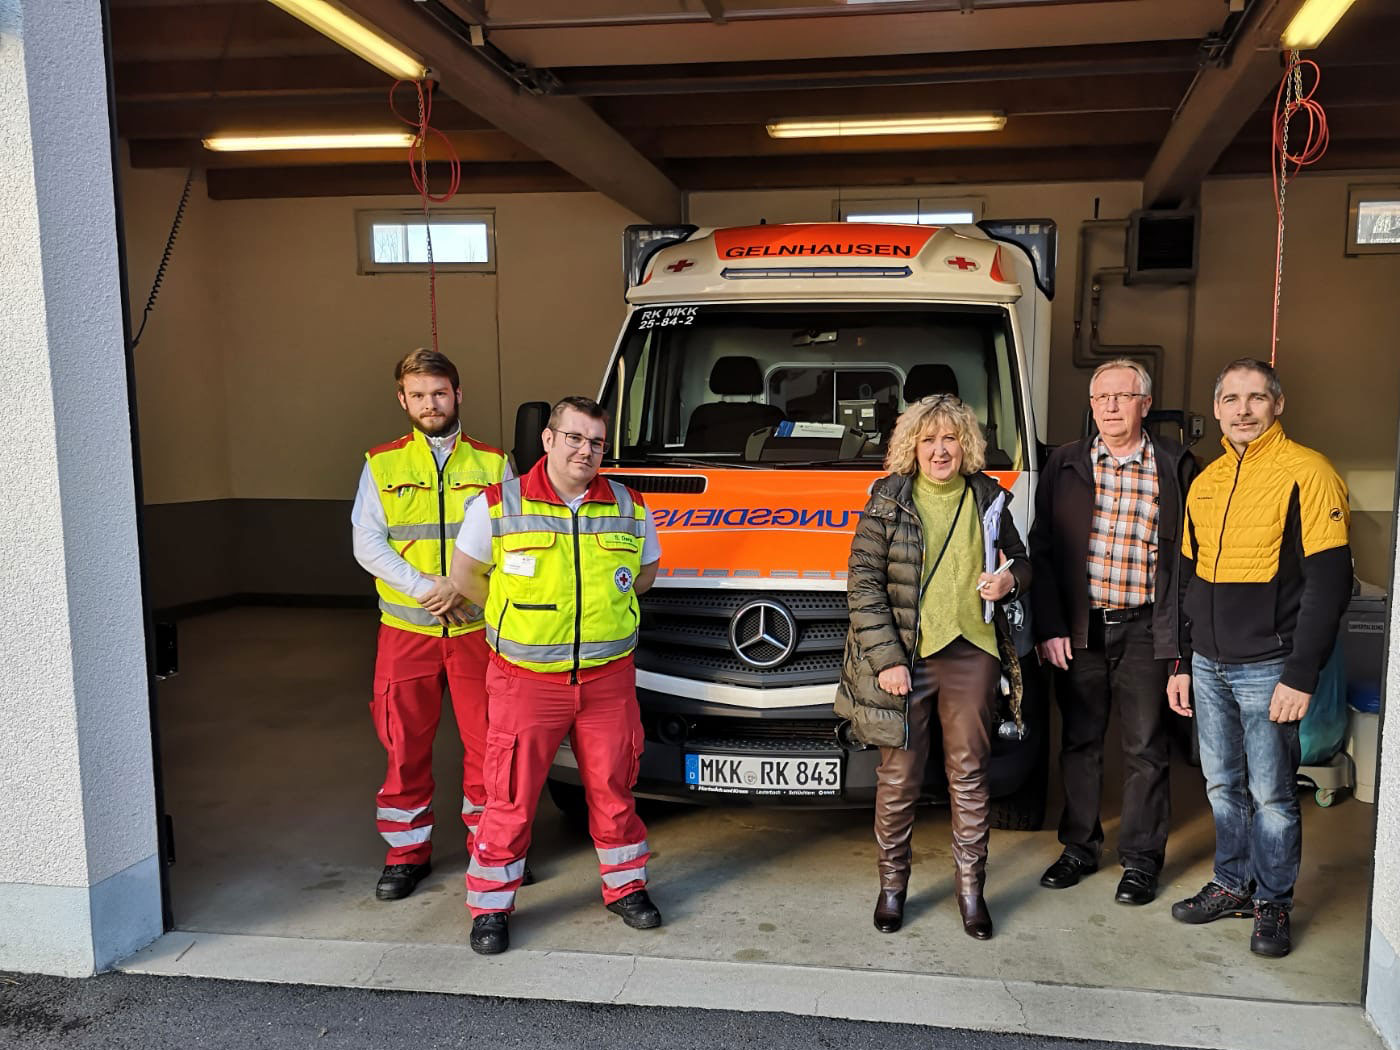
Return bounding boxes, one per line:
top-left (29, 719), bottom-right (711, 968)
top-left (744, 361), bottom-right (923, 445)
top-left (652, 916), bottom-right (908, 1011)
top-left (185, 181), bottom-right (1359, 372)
top-left (466, 654), bottom-right (651, 918)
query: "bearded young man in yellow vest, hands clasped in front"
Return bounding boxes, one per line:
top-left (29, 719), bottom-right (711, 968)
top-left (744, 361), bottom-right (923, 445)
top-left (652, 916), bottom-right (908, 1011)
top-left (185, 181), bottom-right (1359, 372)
top-left (350, 350), bottom-right (511, 900)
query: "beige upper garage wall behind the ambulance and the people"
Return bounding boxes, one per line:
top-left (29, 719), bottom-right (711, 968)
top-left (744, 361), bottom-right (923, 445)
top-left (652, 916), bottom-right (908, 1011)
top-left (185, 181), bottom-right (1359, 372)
top-left (125, 169), bottom-right (1400, 580)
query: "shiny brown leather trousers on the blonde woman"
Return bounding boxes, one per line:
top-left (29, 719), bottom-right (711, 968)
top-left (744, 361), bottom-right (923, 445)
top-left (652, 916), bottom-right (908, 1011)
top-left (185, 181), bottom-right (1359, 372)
top-left (875, 638), bottom-right (1001, 895)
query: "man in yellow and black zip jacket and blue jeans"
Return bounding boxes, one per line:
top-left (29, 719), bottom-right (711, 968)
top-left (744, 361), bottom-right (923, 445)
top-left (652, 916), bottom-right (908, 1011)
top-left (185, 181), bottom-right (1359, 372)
top-left (1168, 358), bottom-right (1352, 958)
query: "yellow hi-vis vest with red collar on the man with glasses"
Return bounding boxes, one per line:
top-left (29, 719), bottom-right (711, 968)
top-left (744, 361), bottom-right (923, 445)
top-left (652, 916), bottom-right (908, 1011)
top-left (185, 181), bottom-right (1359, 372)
top-left (486, 461), bottom-right (647, 672)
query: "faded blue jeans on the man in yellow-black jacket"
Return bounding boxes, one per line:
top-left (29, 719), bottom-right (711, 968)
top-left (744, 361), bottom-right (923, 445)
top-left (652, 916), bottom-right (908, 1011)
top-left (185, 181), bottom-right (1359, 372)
top-left (1191, 652), bottom-right (1302, 907)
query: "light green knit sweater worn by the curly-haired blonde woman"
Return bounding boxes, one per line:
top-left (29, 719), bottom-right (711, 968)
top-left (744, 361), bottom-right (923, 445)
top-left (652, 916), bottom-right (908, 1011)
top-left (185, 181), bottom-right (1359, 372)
top-left (913, 473), bottom-right (997, 659)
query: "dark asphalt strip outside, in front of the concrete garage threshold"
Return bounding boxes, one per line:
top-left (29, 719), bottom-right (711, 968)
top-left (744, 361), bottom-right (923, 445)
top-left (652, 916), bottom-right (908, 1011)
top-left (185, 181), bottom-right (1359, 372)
top-left (0, 973), bottom-right (1204, 1050)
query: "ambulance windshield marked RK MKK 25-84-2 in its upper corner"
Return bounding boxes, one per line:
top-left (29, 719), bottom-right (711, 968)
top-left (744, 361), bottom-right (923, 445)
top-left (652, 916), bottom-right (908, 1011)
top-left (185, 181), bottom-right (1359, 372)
top-left (603, 304), bottom-right (1023, 469)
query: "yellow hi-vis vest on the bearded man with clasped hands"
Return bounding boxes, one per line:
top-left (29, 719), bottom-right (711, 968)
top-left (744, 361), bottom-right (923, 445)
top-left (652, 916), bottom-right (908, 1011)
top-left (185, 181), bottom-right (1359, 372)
top-left (364, 430), bottom-right (505, 637)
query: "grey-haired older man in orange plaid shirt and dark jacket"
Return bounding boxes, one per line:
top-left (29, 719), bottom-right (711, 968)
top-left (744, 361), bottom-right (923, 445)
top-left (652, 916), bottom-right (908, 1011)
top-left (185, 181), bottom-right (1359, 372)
top-left (1030, 358), bottom-right (1197, 904)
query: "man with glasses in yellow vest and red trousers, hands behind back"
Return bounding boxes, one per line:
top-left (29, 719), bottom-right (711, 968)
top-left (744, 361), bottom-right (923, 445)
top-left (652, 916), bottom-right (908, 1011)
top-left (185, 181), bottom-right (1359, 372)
top-left (451, 398), bottom-right (661, 955)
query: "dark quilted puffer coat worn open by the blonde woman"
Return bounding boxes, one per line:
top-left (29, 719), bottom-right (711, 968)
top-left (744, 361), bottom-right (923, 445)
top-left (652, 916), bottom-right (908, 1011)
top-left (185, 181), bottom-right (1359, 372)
top-left (836, 473), bottom-right (1030, 748)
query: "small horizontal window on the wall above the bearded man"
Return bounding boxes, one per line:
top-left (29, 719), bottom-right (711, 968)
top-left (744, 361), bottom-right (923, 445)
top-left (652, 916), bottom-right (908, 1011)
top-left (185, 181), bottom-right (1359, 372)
top-left (356, 210), bottom-right (496, 273)
